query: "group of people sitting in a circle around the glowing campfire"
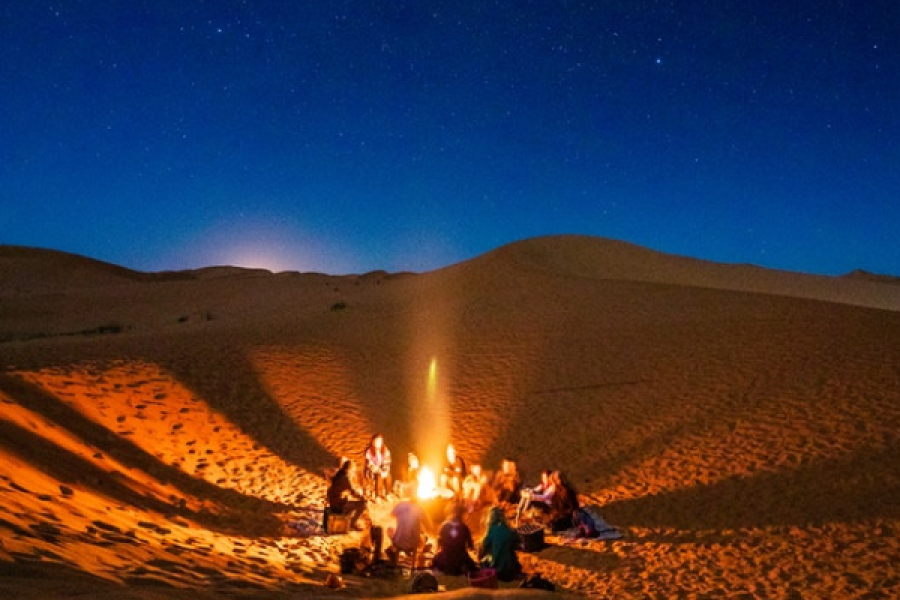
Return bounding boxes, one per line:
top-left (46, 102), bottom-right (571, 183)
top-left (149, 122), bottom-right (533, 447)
top-left (327, 434), bottom-right (579, 581)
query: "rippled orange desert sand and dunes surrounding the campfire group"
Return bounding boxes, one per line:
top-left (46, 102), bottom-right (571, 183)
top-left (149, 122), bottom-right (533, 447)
top-left (0, 236), bottom-right (900, 599)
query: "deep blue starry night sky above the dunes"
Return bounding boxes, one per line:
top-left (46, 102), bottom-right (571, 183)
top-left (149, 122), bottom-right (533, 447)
top-left (0, 0), bottom-right (900, 274)
